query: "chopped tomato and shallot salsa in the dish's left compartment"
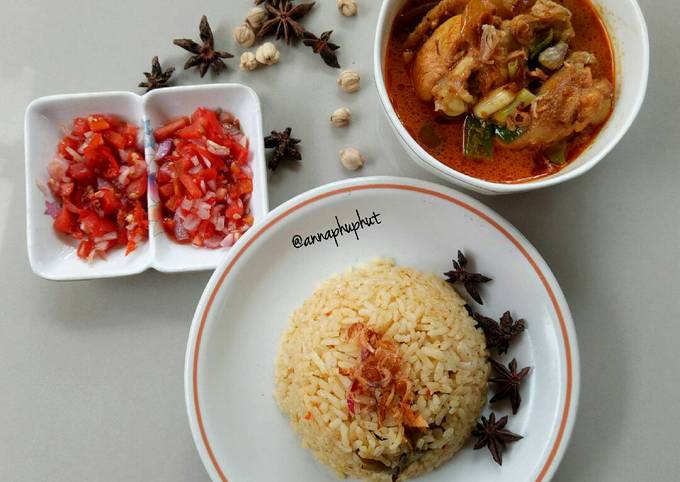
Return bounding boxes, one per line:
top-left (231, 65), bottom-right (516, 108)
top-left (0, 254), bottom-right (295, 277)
top-left (46, 114), bottom-right (149, 261)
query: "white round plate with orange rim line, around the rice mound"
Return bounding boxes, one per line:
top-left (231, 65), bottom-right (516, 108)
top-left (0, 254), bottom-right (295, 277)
top-left (185, 177), bottom-right (579, 482)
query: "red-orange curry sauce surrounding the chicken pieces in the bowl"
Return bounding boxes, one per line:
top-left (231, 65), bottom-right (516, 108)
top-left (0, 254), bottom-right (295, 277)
top-left (385, 0), bottom-right (615, 183)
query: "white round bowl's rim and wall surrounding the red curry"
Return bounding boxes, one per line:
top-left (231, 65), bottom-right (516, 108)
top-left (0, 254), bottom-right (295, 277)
top-left (373, 0), bottom-right (649, 194)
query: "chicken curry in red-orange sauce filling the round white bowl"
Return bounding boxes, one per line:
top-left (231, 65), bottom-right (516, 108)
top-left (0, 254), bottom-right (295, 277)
top-left (385, 0), bottom-right (614, 183)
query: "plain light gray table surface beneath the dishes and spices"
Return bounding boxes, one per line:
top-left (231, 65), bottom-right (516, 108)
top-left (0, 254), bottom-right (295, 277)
top-left (0, 0), bottom-right (680, 482)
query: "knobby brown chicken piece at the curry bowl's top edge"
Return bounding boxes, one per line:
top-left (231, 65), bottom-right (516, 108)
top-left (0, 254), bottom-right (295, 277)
top-left (502, 0), bottom-right (576, 47)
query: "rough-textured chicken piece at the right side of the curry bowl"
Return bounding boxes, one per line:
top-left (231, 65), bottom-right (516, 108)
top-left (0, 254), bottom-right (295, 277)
top-left (506, 51), bottom-right (614, 149)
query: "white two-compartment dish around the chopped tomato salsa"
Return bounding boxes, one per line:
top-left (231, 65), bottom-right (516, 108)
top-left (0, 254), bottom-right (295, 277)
top-left (25, 84), bottom-right (268, 280)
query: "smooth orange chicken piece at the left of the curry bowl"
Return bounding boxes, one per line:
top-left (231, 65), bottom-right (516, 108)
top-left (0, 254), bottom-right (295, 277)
top-left (412, 15), bottom-right (465, 102)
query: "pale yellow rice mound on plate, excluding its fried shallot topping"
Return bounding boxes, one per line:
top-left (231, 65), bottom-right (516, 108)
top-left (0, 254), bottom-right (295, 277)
top-left (276, 260), bottom-right (489, 481)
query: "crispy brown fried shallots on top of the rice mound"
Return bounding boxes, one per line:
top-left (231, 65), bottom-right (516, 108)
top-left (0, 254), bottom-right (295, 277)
top-left (340, 323), bottom-right (427, 428)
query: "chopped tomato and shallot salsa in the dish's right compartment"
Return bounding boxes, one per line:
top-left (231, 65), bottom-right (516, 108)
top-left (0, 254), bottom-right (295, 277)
top-left (154, 107), bottom-right (253, 248)
